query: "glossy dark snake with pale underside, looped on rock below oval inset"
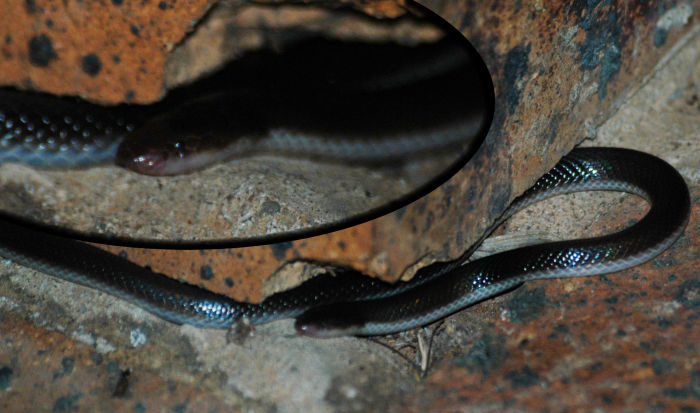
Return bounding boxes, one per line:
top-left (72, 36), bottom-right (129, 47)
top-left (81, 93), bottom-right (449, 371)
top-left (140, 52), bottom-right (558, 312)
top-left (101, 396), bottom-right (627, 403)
top-left (0, 148), bottom-right (690, 337)
